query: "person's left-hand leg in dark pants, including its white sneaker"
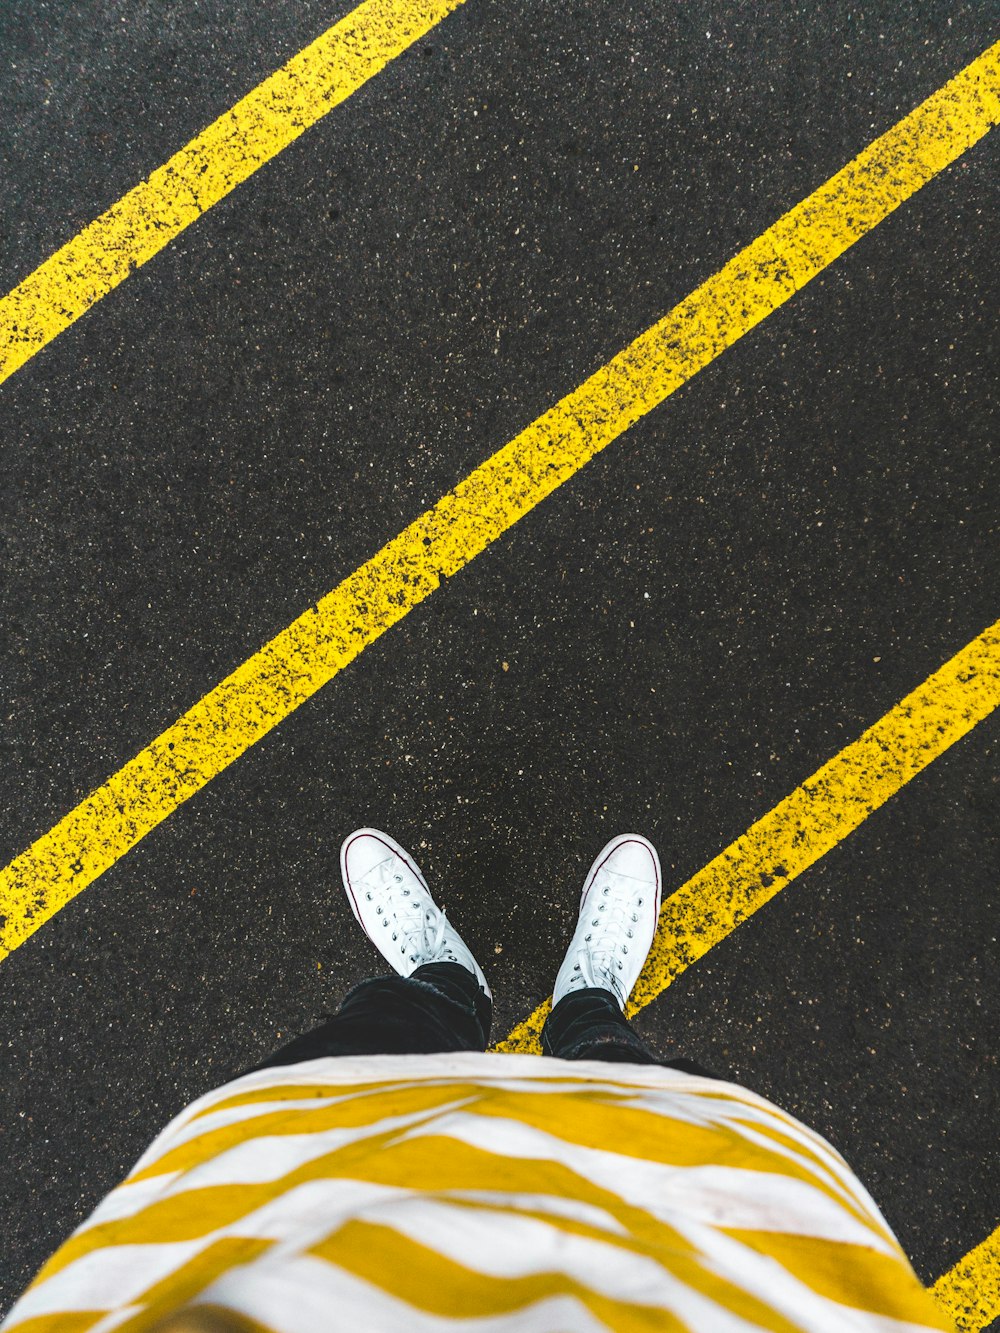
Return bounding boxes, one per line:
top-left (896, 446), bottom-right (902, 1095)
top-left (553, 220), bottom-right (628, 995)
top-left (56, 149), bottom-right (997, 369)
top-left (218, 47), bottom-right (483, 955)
top-left (256, 829), bottom-right (493, 1069)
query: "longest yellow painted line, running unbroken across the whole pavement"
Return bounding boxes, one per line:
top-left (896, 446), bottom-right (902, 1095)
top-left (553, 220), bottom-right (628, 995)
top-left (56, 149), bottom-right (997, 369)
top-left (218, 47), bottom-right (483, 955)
top-left (0, 43), bottom-right (1000, 958)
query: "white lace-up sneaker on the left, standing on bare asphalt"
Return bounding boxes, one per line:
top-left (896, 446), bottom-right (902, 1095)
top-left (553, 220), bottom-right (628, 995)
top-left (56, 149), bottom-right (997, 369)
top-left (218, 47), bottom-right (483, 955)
top-left (340, 829), bottom-right (491, 996)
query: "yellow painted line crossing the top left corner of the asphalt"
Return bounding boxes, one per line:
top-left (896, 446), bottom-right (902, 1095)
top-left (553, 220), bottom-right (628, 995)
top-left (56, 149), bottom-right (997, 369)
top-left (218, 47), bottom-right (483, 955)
top-left (0, 0), bottom-right (463, 383)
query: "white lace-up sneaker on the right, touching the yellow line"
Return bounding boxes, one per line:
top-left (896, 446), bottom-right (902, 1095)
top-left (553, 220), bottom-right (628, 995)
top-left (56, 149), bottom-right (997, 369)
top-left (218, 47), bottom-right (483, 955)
top-left (552, 833), bottom-right (661, 1009)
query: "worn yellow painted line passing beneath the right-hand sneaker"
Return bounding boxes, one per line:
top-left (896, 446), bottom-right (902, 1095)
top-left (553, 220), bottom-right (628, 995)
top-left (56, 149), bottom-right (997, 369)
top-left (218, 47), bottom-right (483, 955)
top-left (495, 620), bottom-right (1000, 1052)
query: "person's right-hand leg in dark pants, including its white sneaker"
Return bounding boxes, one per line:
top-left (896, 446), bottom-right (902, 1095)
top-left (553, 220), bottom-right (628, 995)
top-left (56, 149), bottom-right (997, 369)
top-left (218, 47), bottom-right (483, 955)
top-left (541, 834), bottom-right (715, 1078)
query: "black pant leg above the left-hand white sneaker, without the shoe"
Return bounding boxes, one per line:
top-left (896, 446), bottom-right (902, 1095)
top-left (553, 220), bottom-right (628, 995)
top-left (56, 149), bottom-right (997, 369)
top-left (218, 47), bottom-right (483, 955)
top-left (255, 962), bottom-right (493, 1069)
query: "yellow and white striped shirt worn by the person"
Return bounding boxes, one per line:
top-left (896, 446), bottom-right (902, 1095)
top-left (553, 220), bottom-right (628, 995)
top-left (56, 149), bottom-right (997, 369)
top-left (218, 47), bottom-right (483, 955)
top-left (3, 1053), bottom-right (952, 1333)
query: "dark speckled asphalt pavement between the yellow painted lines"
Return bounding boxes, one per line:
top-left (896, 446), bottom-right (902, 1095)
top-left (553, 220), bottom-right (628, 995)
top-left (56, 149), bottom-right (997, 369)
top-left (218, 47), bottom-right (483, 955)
top-left (0, 0), bottom-right (1000, 1310)
